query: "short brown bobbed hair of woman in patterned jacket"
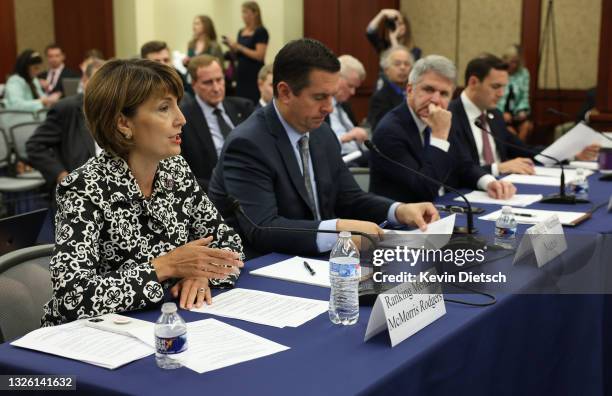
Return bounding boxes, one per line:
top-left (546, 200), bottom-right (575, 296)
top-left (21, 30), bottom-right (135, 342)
top-left (83, 59), bottom-right (183, 158)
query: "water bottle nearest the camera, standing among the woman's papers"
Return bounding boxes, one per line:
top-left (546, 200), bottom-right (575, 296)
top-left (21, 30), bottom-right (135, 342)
top-left (155, 303), bottom-right (187, 369)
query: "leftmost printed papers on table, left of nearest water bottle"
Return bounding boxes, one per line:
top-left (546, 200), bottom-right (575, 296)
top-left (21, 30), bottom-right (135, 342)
top-left (11, 319), bottom-right (153, 370)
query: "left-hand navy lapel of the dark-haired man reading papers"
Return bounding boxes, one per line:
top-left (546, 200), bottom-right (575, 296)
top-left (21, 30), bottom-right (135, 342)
top-left (264, 106), bottom-right (314, 217)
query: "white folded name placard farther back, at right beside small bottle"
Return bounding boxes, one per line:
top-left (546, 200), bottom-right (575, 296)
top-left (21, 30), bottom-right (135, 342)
top-left (512, 215), bottom-right (567, 268)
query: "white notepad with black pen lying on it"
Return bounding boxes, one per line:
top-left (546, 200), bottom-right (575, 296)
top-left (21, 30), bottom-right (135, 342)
top-left (251, 256), bottom-right (331, 288)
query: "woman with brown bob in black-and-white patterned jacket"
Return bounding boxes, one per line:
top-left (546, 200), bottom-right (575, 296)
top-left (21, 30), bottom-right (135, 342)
top-left (42, 60), bottom-right (243, 326)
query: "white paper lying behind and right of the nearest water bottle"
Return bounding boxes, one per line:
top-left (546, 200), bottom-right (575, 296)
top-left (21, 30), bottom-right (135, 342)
top-left (130, 319), bottom-right (290, 374)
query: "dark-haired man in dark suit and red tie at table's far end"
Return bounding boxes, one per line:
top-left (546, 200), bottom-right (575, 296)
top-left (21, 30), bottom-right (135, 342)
top-left (448, 54), bottom-right (599, 176)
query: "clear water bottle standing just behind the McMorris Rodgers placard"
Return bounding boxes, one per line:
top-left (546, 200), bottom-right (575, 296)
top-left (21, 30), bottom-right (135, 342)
top-left (329, 231), bottom-right (361, 325)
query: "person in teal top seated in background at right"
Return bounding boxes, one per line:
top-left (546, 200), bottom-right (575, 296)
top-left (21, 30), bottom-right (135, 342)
top-left (497, 45), bottom-right (533, 141)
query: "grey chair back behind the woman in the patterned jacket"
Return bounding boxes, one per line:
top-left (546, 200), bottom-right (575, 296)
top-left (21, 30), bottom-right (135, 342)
top-left (0, 244), bottom-right (53, 343)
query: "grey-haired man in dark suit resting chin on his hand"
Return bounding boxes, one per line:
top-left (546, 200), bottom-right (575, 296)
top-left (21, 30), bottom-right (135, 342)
top-left (370, 55), bottom-right (516, 202)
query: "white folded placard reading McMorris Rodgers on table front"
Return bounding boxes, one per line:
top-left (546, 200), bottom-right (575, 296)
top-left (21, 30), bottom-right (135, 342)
top-left (363, 269), bottom-right (446, 347)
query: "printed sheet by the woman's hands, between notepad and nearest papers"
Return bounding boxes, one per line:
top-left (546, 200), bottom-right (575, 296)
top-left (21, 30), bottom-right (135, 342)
top-left (192, 288), bottom-right (329, 328)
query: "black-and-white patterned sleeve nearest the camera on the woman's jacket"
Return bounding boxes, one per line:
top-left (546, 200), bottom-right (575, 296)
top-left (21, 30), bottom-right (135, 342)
top-left (43, 174), bottom-right (164, 322)
